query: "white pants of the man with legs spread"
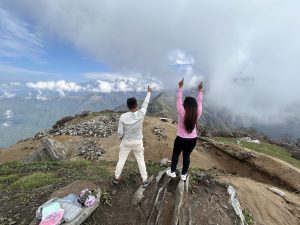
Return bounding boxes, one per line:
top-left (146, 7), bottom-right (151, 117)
top-left (115, 140), bottom-right (148, 181)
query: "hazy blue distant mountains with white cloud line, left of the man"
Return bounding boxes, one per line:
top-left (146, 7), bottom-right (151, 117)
top-left (0, 74), bottom-right (160, 147)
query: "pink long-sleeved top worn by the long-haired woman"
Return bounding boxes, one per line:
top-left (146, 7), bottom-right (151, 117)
top-left (176, 88), bottom-right (202, 138)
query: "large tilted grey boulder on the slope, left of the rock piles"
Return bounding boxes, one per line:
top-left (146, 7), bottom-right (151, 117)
top-left (41, 138), bottom-right (67, 160)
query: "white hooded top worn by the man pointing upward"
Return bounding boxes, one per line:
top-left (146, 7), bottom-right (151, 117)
top-left (118, 92), bottom-right (151, 141)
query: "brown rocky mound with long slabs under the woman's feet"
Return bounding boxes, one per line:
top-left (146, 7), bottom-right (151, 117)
top-left (132, 170), bottom-right (244, 225)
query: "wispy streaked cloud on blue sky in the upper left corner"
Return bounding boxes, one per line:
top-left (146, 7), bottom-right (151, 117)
top-left (0, 8), bottom-right (44, 61)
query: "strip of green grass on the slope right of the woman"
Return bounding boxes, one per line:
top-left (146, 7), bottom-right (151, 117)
top-left (214, 137), bottom-right (300, 169)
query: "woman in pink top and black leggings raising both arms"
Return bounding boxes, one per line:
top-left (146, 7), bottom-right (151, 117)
top-left (166, 79), bottom-right (203, 180)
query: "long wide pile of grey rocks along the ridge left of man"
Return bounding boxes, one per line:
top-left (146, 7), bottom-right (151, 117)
top-left (34, 114), bottom-right (119, 139)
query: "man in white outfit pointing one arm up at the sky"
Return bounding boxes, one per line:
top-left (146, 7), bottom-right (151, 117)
top-left (113, 86), bottom-right (152, 187)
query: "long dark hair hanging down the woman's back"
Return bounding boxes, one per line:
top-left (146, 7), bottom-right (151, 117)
top-left (183, 97), bottom-right (198, 133)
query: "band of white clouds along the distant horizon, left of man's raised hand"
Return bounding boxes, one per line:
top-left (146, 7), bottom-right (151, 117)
top-left (0, 76), bottom-right (161, 101)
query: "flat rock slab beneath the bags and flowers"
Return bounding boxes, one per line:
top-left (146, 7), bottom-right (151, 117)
top-left (30, 181), bottom-right (101, 225)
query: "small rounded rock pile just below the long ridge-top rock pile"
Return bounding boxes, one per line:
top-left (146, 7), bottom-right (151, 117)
top-left (79, 139), bottom-right (105, 161)
